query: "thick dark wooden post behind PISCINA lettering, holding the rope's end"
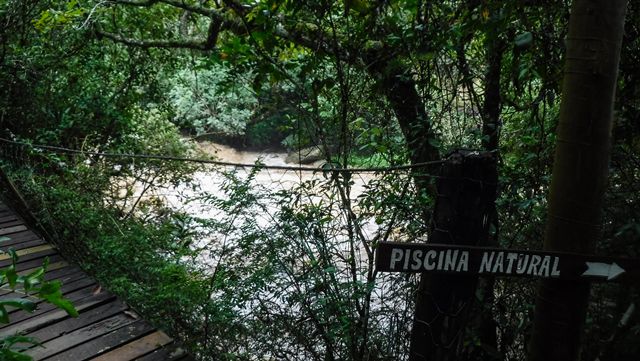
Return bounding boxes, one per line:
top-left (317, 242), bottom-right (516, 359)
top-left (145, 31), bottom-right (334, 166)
top-left (409, 152), bottom-right (496, 361)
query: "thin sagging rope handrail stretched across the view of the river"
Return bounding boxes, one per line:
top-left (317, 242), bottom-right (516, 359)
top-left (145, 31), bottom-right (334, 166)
top-left (0, 138), bottom-right (446, 173)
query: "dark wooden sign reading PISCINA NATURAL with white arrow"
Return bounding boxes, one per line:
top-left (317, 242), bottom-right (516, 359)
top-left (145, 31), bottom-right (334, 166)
top-left (376, 242), bottom-right (640, 282)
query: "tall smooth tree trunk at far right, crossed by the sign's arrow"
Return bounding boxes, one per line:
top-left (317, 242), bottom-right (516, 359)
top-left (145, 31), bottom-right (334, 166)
top-left (528, 0), bottom-right (626, 361)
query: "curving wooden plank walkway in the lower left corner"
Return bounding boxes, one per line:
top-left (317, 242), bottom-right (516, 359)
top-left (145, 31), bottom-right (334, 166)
top-left (0, 202), bottom-right (193, 361)
